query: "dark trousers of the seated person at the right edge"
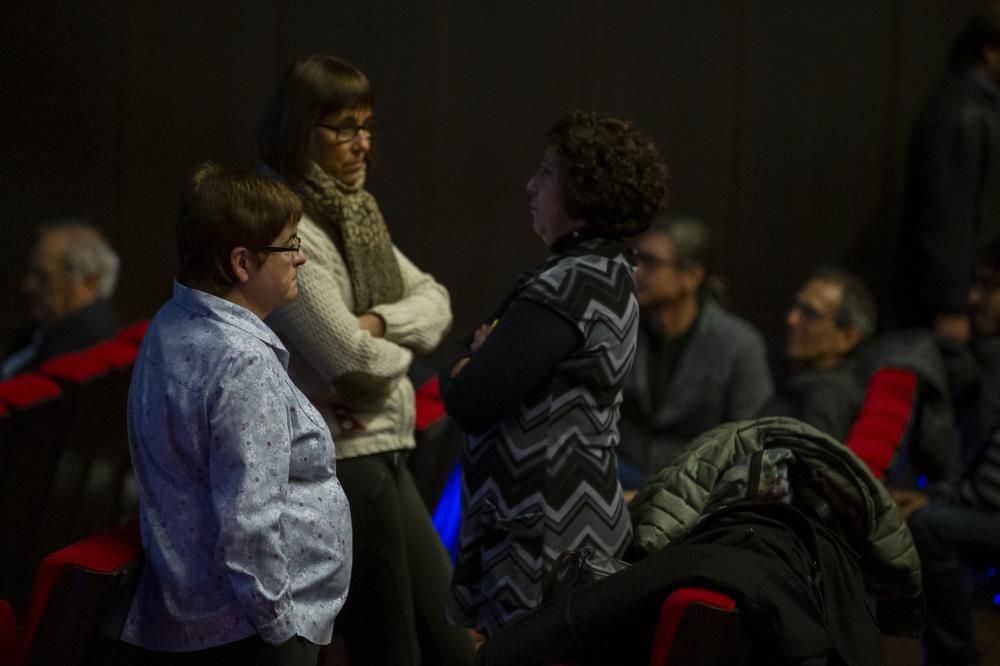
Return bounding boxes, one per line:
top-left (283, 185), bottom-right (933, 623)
top-left (909, 502), bottom-right (1000, 666)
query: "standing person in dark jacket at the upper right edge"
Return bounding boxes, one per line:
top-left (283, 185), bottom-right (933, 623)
top-left (893, 6), bottom-right (1000, 344)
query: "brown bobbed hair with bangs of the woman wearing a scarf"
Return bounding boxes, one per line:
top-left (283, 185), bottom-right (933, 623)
top-left (257, 55), bottom-right (375, 178)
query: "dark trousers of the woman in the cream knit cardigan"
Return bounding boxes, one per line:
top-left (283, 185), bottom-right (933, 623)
top-left (334, 452), bottom-right (475, 666)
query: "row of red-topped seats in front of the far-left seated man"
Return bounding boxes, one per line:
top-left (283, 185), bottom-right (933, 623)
top-left (0, 321), bottom-right (148, 612)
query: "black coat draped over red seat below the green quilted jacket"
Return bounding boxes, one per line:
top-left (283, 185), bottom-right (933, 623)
top-left (478, 504), bottom-right (885, 666)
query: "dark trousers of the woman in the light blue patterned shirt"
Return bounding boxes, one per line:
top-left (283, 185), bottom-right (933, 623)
top-left (112, 636), bottom-right (319, 666)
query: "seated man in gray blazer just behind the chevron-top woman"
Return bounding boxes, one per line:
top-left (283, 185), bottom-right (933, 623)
top-left (620, 216), bottom-right (774, 488)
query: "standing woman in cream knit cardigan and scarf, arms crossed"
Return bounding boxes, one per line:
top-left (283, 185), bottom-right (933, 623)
top-left (258, 55), bottom-right (474, 666)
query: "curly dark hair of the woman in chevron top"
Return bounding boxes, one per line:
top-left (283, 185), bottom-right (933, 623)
top-left (548, 111), bottom-right (667, 236)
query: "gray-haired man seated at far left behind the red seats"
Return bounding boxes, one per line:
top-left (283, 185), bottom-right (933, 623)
top-left (0, 219), bottom-right (121, 379)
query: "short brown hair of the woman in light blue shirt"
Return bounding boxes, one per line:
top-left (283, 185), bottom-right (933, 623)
top-left (177, 162), bottom-right (302, 296)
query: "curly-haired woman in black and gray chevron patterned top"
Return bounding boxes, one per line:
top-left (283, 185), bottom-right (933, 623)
top-left (442, 111), bottom-right (666, 636)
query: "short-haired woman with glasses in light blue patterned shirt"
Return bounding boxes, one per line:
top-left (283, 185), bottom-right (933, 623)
top-left (122, 163), bottom-right (351, 666)
